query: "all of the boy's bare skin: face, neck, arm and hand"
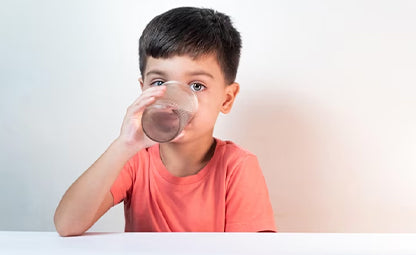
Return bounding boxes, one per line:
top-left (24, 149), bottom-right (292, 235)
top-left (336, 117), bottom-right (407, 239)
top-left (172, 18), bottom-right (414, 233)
top-left (54, 54), bottom-right (239, 236)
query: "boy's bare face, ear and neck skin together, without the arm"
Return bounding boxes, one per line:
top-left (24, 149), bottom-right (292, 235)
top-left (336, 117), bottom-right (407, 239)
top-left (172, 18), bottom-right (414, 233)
top-left (140, 54), bottom-right (239, 176)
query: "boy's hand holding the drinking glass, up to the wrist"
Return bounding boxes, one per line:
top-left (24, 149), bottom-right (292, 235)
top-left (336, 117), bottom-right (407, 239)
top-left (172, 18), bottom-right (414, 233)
top-left (117, 86), bottom-right (166, 151)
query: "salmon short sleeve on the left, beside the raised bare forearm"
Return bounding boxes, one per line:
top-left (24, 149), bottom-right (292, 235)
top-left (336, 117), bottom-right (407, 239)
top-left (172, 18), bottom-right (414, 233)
top-left (110, 154), bottom-right (138, 205)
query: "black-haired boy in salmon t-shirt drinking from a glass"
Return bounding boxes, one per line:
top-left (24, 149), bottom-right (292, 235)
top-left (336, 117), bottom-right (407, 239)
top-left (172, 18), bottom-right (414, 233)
top-left (54, 7), bottom-right (276, 236)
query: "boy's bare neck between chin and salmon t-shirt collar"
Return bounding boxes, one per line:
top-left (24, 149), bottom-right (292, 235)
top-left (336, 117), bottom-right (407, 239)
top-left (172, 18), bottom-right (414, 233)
top-left (159, 136), bottom-right (215, 177)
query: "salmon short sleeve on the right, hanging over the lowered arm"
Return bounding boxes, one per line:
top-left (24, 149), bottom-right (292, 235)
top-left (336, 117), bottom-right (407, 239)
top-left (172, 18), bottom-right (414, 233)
top-left (225, 154), bottom-right (276, 232)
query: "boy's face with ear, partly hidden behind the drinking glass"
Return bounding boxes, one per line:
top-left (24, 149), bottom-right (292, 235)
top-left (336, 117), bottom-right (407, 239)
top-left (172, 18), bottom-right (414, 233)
top-left (140, 54), bottom-right (239, 142)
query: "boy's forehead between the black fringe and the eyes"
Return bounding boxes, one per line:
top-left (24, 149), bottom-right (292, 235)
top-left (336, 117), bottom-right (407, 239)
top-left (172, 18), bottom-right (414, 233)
top-left (143, 54), bottom-right (224, 80)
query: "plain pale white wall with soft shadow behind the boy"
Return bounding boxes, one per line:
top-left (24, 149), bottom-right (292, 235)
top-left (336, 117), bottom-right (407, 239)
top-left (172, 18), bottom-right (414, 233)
top-left (0, 0), bottom-right (416, 232)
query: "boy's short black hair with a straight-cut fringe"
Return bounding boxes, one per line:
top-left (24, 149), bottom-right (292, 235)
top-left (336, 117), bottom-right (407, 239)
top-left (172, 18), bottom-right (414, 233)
top-left (139, 7), bottom-right (241, 84)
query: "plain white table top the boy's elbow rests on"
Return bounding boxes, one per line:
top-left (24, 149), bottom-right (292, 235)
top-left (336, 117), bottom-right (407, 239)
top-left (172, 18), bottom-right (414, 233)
top-left (0, 231), bottom-right (416, 255)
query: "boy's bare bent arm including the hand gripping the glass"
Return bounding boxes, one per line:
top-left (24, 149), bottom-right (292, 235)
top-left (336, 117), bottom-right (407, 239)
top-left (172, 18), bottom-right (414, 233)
top-left (54, 86), bottom-right (165, 236)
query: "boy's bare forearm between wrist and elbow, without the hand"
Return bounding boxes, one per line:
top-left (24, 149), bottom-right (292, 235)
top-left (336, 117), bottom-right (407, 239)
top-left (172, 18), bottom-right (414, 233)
top-left (54, 140), bottom-right (137, 234)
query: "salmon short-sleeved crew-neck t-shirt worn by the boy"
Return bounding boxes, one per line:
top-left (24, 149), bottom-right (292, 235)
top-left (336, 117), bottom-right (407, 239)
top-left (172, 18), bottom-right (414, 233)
top-left (111, 139), bottom-right (276, 232)
